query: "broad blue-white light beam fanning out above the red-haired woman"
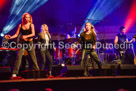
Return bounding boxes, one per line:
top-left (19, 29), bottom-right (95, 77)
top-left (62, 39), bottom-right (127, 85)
top-left (2, 0), bottom-right (48, 34)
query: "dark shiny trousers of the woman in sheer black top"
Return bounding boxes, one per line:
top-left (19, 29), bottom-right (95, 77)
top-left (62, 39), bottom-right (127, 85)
top-left (81, 49), bottom-right (102, 74)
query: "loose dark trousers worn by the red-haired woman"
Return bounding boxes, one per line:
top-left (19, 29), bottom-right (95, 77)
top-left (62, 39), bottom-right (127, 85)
top-left (12, 41), bottom-right (39, 74)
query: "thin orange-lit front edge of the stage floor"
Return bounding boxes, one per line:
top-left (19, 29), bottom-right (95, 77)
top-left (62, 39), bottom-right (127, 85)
top-left (0, 76), bottom-right (136, 83)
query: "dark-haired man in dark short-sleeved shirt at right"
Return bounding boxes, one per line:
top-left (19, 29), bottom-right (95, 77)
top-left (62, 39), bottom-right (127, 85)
top-left (114, 26), bottom-right (128, 63)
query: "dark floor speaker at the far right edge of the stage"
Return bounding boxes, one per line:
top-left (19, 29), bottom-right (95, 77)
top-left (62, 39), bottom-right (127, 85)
top-left (117, 64), bottom-right (136, 76)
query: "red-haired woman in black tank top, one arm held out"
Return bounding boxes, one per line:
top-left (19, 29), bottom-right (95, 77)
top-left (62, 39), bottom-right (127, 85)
top-left (5, 13), bottom-right (39, 79)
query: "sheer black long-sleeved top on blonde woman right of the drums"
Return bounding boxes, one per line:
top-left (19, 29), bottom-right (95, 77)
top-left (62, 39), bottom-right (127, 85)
top-left (79, 32), bottom-right (96, 49)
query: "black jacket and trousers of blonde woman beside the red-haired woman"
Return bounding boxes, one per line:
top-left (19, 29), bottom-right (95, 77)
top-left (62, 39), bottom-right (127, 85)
top-left (38, 34), bottom-right (53, 71)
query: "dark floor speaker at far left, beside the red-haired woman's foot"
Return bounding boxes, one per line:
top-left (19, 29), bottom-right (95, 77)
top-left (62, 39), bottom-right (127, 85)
top-left (0, 67), bottom-right (11, 80)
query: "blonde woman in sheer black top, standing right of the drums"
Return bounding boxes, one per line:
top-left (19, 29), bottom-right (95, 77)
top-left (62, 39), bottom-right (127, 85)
top-left (79, 22), bottom-right (102, 76)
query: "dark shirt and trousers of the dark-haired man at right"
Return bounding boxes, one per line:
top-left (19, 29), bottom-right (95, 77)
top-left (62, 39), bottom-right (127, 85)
top-left (116, 33), bottom-right (127, 63)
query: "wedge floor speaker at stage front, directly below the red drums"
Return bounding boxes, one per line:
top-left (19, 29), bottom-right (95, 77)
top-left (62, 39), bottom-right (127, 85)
top-left (60, 65), bottom-right (84, 77)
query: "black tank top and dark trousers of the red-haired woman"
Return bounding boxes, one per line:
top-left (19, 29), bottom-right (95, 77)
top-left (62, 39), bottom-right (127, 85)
top-left (13, 24), bottom-right (39, 74)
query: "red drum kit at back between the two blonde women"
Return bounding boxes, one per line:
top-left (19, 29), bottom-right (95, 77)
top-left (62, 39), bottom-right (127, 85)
top-left (53, 35), bottom-right (81, 65)
